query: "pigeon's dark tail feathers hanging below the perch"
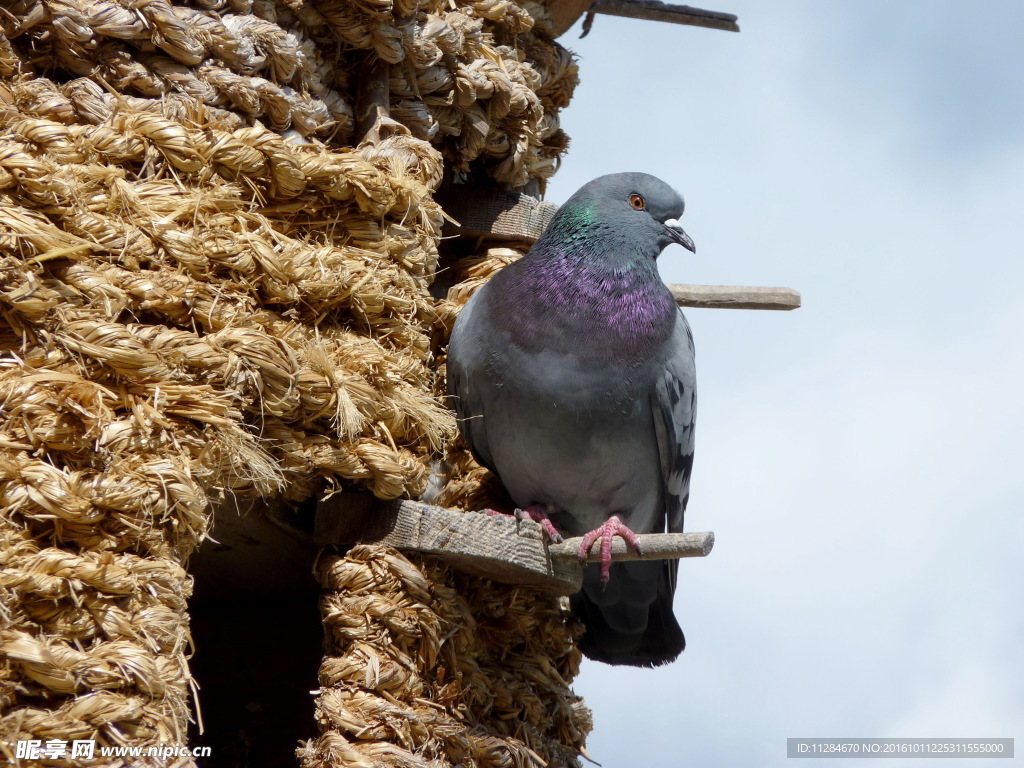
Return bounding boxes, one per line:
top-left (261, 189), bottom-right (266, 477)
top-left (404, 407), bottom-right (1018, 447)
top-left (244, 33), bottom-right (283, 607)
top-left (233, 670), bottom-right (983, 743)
top-left (569, 560), bottom-right (686, 667)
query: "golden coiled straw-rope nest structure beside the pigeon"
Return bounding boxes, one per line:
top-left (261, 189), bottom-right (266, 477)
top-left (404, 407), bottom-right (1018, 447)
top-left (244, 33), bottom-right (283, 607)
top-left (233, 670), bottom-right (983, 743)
top-left (0, 0), bottom-right (589, 767)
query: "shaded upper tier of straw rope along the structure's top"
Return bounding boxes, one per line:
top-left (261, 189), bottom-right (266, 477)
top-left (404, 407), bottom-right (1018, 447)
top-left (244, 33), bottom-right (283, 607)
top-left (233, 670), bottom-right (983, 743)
top-left (0, 0), bottom-right (578, 186)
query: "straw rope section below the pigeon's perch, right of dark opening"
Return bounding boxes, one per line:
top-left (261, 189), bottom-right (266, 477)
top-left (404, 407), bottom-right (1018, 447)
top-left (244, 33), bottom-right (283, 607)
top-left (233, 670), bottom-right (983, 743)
top-left (299, 546), bottom-right (591, 768)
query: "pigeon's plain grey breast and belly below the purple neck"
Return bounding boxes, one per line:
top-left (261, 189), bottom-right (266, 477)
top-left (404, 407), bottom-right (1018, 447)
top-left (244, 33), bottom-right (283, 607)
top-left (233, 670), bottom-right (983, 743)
top-left (450, 280), bottom-right (664, 536)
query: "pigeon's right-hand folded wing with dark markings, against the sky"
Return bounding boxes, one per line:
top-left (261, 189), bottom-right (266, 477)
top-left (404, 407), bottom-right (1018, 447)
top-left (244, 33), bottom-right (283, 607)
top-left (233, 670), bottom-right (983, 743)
top-left (651, 310), bottom-right (697, 540)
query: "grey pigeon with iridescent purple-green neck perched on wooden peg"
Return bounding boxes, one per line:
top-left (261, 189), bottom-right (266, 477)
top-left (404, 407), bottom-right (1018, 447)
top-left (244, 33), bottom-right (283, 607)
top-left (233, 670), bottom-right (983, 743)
top-left (447, 173), bottom-right (696, 667)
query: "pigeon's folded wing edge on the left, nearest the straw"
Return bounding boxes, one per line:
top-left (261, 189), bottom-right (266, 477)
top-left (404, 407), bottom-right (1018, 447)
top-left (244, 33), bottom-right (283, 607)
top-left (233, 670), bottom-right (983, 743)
top-left (446, 286), bottom-right (495, 471)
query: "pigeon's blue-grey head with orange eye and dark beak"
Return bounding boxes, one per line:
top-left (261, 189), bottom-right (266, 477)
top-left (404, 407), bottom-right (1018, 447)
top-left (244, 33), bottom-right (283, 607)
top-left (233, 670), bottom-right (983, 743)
top-left (564, 173), bottom-right (696, 253)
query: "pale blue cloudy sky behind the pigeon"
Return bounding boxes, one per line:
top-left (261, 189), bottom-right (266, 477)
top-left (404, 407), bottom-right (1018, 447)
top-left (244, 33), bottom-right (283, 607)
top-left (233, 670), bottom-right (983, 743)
top-left (547, 0), bottom-right (1024, 768)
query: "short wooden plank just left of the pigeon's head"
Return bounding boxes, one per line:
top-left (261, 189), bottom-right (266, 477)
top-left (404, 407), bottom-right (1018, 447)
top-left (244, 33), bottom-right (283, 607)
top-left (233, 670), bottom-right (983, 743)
top-left (441, 185), bottom-right (558, 245)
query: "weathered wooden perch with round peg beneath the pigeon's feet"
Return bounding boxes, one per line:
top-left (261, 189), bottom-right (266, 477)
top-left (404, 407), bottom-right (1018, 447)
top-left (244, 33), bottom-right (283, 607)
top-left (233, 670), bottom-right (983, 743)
top-left (315, 494), bottom-right (715, 595)
